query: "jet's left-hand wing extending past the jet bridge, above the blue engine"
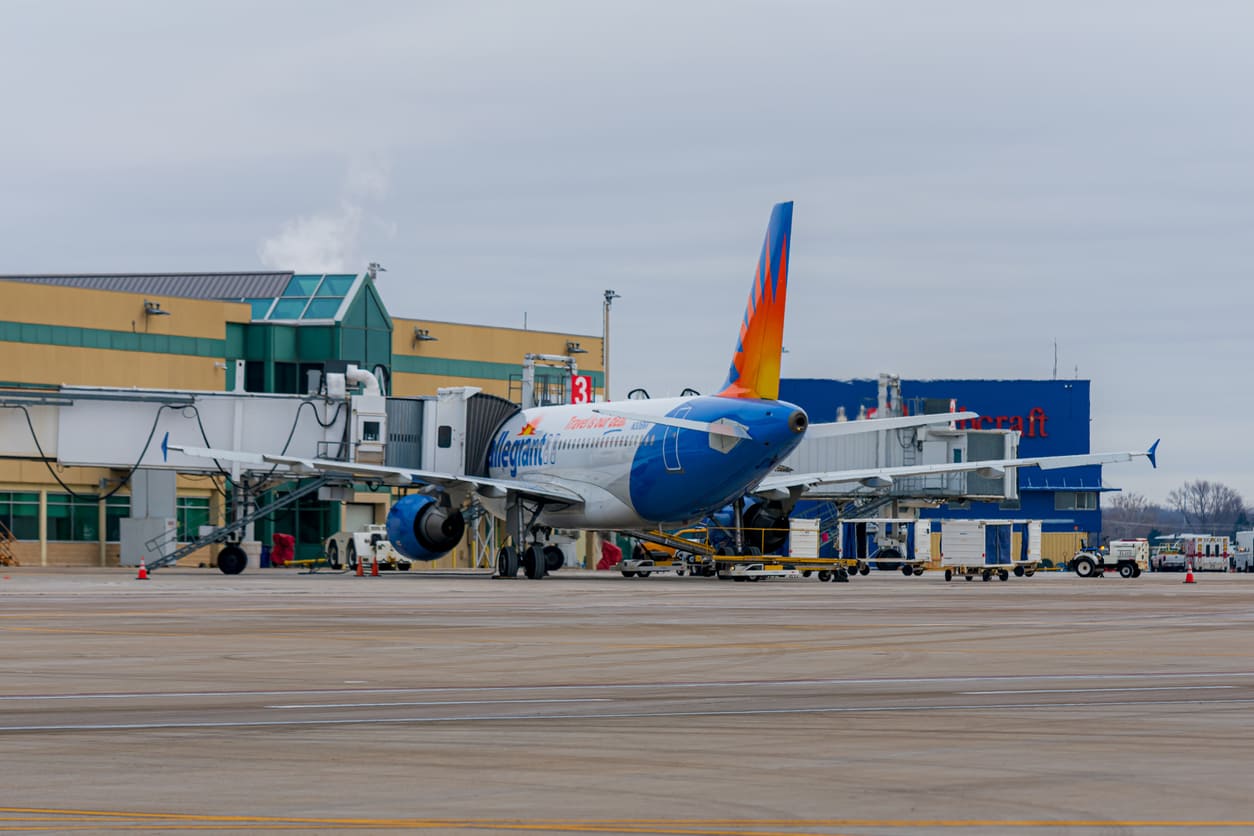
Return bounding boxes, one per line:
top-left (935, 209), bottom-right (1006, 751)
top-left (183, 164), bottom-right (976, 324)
top-left (162, 442), bottom-right (583, 505)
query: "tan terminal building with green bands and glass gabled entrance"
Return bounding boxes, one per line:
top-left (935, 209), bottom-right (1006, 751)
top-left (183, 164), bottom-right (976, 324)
top-left (0, 272), bottom-right (604, 568)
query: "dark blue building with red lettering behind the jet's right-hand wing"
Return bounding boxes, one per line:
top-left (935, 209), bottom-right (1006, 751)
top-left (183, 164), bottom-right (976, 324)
top-left (780, 379), bottom-right (1110, 560)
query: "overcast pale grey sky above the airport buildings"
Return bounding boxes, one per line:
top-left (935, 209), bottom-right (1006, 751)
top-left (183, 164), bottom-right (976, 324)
top-left (0, 0), bottom-right (1254, 503)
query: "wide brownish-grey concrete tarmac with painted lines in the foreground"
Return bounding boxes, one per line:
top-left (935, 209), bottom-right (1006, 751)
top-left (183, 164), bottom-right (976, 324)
top-left (0, 568), bottom-right (1254, 836)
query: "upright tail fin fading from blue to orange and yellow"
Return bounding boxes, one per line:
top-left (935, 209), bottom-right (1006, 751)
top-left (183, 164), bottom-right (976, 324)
top-left (719, 201), bottom-right (793, 400)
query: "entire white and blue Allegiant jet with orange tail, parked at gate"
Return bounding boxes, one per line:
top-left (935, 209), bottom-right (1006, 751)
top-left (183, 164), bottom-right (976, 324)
top-left (168, 203), bottom-right (1154, 578)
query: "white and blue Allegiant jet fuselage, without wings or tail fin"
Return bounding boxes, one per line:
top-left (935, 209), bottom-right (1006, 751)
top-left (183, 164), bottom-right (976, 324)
top-left (484, 396), bottom-right (806, 529)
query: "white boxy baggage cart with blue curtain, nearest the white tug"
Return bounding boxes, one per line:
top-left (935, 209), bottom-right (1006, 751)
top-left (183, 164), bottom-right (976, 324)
top-left (941, 520), bottom-right (1041, 580)
